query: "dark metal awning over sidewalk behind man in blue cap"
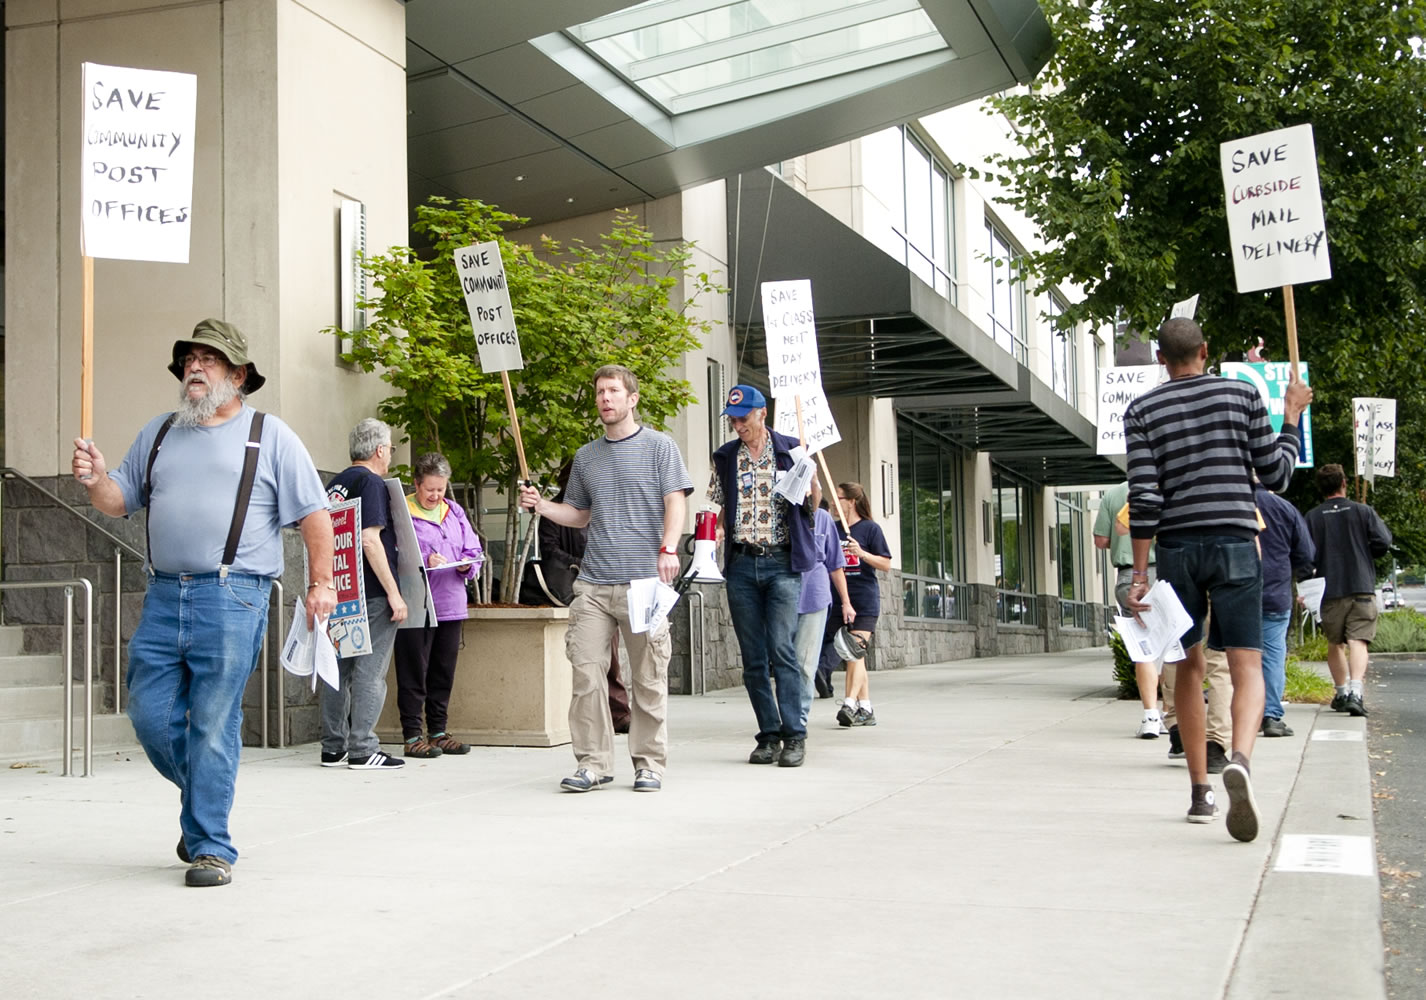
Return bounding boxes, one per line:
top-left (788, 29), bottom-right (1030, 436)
top-left (729, 170), bottom-right (1124, 486)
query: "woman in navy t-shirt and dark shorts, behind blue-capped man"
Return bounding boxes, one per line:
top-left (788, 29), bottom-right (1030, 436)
top-left (829, 482), bottom-right (891, 726)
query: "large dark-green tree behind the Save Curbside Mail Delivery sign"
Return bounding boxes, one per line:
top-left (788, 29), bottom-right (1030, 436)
top-left (990, 0), bottom-right (1426, 559)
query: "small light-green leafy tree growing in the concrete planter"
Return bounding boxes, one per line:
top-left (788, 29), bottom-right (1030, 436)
top-left (328, 197), bottom-right (722, 595)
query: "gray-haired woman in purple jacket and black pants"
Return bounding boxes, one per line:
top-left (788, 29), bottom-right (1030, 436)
top-left (396, 451), bottom-right (485, 757)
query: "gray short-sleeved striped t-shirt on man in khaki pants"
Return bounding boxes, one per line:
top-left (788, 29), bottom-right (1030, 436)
top-left (565, 427), bottom-right (693, 583)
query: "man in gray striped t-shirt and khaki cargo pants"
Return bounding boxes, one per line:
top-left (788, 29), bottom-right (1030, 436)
top-left (520, 365), bottom-right (693, 792)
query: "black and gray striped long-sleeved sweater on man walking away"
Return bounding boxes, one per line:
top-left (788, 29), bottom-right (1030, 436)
top-left (1124, 375), bottom-right (1298, 538)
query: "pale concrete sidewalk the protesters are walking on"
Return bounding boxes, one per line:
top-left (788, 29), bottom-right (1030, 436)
top-left (0, 649), bottom-right (1385, 1000)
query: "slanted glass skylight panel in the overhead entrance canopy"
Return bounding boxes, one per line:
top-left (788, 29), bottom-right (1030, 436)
top-left (568, 0), bottom-right (951, 114)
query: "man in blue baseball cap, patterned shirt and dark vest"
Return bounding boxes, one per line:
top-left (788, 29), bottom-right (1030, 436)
top-left (709, 385), bottom-right (817, 767)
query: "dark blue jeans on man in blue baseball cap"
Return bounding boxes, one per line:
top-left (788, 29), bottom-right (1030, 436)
top-left (727, 552), bottom-right (807, 743)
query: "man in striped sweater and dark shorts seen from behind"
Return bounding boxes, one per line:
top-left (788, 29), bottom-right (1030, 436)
top-left (1124, 318), bottom-right (1312, 840)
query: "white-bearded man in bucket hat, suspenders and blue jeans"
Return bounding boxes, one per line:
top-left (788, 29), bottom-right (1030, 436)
top-left (73, 320), bottom-right (337, 886)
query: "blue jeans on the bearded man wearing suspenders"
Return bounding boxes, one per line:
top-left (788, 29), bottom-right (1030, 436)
top-left (128, 573), bottom-right (272, 864)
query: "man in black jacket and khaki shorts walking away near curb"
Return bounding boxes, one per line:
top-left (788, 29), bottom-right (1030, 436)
top-left (1308, 465), bottom-right (1392, 716)
